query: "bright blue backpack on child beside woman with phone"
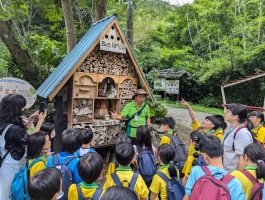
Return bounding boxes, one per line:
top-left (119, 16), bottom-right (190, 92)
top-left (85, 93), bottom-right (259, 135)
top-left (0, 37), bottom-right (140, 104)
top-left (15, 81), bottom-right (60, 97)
top-left (10, 158), bottom-right (44, 200)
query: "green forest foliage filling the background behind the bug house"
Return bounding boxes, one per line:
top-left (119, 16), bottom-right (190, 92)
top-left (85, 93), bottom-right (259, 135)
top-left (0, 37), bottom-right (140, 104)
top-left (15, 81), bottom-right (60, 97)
top-left (0, 0), bottom-right (265, 106)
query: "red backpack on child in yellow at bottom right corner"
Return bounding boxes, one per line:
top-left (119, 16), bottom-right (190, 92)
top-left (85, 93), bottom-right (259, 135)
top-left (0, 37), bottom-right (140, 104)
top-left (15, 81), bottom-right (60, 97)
top-left (241, 170), bottom-right (264, 200)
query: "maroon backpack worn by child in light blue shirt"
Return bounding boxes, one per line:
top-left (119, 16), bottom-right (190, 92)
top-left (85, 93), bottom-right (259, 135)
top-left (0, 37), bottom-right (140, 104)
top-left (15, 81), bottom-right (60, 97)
top-left (190, 166), bottom-right (234, 200)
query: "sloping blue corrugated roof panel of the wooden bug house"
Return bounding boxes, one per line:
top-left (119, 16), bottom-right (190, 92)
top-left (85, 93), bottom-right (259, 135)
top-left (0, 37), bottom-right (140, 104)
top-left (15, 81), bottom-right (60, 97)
top-left (37, 14), bottom-right (117, 98)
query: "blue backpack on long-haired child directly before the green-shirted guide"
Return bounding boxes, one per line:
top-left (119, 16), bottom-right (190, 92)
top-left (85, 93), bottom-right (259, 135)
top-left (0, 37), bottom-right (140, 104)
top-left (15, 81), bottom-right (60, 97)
top-left (137, 149), bottom-right (156, 184)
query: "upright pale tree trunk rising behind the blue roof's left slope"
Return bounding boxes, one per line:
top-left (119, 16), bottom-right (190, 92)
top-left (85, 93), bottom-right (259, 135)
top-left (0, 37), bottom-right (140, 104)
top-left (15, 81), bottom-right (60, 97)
top-left (61, 0), bottom-right (76, 53)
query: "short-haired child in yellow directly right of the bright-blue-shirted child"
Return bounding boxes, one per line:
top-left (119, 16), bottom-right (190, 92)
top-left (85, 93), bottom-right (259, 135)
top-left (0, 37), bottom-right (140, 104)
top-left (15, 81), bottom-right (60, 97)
top-left (68, 152), bottom-right (104, 200)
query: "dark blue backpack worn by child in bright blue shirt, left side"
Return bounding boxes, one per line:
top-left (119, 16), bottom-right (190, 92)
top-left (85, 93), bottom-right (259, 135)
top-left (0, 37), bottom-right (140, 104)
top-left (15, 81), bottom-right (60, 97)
top-left (53, 154), bottom-right (76, 200)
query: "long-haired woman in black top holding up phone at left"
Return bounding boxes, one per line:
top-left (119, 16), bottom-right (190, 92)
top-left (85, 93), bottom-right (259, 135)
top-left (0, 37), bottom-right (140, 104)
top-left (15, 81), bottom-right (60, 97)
top-left (0, 94), bottom-right (46, 199)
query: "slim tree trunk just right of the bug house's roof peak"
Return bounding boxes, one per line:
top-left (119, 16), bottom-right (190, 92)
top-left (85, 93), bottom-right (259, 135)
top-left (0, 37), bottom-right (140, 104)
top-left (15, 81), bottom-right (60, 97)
top-left (127, 0), bottom-right (134, 48)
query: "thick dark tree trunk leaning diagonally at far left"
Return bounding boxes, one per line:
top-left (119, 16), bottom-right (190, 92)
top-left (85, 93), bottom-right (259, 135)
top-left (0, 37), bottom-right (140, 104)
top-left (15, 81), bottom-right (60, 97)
top-left (0, 20), bottom-right (40, 87)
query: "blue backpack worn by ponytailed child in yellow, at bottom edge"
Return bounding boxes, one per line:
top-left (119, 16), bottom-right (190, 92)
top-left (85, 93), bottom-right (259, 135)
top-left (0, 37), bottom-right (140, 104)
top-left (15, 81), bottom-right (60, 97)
top-left (157, 172), bottom-right (185, 200)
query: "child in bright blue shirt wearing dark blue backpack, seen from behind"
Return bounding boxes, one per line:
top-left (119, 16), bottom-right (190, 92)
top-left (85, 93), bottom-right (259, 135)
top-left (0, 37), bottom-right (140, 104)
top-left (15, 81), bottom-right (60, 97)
top-left (46, 128), bottom-right (83, 200)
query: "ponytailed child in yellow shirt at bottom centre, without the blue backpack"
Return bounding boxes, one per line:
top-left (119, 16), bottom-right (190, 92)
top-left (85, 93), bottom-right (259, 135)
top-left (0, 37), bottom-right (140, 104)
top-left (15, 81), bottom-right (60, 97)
top-left (149, 144), bottom-right (184, 200)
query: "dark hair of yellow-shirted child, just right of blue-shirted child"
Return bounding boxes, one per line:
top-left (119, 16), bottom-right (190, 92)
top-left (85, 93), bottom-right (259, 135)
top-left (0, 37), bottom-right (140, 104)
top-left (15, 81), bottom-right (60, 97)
top-left (77, 152), bottom-right (104, 183)
